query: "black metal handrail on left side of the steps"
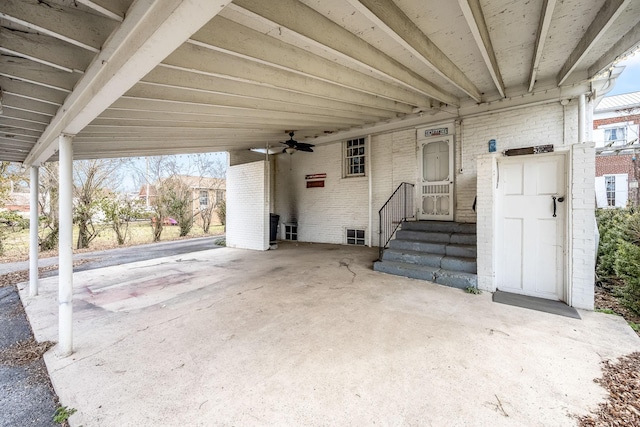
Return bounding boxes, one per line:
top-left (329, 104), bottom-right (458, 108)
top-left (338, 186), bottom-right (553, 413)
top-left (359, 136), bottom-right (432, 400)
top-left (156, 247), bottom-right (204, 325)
top-left (378, 182), bottom-right (415, 259)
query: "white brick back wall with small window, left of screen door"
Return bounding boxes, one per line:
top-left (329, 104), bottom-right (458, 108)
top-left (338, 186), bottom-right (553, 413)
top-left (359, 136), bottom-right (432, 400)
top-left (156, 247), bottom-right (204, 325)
top-left (275, 129), bottom-right (417, 246)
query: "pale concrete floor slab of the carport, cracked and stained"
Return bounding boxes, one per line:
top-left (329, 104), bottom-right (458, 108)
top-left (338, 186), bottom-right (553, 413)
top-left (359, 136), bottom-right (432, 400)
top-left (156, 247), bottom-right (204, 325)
top-left (17, 244), bottom-right (640, 427)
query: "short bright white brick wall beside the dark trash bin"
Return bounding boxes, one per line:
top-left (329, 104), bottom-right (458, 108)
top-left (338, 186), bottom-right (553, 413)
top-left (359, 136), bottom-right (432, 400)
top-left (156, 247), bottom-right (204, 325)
top-left (226, 162), bottom-right (269, 251)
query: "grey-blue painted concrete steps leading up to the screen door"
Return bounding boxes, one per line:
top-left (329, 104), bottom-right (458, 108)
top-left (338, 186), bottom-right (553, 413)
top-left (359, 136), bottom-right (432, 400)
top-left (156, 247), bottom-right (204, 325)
top-left (373, 221), bottom-right (477, 289)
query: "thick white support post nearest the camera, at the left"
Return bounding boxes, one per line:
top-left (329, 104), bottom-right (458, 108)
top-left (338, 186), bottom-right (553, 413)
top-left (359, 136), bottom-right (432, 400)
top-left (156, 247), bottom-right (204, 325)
top-left (58, 135), bottom-right (73, 357)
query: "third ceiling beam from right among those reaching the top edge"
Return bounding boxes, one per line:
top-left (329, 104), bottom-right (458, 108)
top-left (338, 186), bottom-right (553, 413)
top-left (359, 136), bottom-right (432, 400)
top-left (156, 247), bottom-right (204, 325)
top-left (458, 0), bottom-right (505, 98)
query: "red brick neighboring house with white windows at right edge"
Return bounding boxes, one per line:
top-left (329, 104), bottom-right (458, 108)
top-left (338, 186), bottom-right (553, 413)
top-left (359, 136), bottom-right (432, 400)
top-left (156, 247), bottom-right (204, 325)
top-left (593, 92), bottom-right (640, 208)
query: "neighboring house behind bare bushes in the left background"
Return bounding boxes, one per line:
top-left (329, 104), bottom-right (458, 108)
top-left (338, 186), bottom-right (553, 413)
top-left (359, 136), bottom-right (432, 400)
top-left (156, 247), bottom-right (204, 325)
top-left (139, 175), bottom-right (226, 224)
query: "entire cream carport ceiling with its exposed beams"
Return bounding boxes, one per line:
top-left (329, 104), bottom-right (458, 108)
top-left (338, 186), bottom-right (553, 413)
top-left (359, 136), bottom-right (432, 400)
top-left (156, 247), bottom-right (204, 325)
top-left (0, 0), bottom-right (640, 164)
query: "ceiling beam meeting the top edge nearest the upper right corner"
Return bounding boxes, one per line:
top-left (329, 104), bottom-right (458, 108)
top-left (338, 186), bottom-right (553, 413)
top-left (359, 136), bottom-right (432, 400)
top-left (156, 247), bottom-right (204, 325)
top-left (557, 0), bottom-right (631, 86)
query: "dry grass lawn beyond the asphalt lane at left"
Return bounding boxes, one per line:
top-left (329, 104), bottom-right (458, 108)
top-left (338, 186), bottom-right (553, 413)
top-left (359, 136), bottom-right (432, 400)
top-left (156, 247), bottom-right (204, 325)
top-left (0, 221), bottom-right (224, 262)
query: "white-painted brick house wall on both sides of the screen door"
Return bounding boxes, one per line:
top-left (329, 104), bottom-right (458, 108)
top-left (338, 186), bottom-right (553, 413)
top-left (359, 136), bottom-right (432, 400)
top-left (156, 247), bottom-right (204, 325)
top-left (268, 102), bottom-right (595, 309)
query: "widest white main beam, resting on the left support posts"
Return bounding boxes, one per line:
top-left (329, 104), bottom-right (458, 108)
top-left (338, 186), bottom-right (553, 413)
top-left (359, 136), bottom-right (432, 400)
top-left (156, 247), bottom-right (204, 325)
top-left (26, 0), bottom-right (236, 164)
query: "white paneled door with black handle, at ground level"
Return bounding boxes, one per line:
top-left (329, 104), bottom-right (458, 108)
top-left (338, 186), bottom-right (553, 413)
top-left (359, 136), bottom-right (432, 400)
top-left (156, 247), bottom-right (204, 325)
top-left (496, 154), bottom-right (567, 300)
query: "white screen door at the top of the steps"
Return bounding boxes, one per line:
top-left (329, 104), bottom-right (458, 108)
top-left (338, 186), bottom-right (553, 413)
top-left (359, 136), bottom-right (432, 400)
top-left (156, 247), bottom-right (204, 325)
top-left (418, 136), bottom-right (453, 221)
